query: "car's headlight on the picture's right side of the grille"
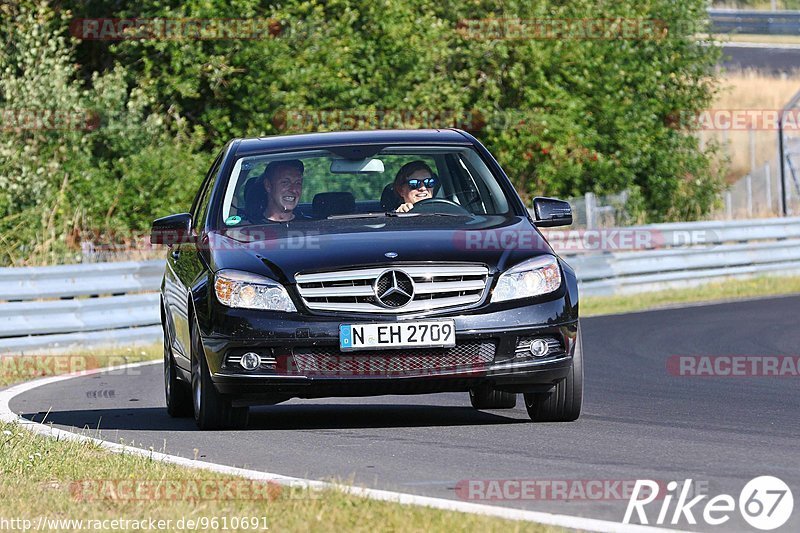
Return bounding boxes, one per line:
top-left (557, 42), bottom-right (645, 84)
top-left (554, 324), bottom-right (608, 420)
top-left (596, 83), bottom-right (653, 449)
top-left (492, 255), bottom-right (561, 302)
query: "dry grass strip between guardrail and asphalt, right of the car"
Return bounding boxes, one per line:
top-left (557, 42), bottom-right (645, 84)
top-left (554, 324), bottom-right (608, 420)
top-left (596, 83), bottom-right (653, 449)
top-left (581, 276), bottom-right (800, 316)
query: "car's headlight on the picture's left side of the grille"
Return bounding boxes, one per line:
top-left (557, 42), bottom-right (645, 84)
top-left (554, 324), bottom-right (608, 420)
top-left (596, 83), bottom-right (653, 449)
top-left (214, 270), bottom-right (297, 312)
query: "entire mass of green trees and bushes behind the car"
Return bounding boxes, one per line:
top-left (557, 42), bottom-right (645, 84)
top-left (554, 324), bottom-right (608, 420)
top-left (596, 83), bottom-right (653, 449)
top-left (0, 0), bottom-right (722, 264)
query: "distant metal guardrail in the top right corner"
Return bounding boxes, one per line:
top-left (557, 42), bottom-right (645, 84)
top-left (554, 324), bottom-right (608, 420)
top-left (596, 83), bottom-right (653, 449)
top-left (708, 9), bottom-right (800, 35)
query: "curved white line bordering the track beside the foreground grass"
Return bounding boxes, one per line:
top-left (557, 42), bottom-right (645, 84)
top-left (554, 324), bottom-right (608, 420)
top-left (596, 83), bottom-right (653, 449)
top-left (0, 360), bottom-right (688, 533)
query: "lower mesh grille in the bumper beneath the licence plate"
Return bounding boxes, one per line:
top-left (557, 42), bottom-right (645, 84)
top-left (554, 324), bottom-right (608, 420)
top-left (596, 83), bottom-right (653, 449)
top-left (289, 341), bottom-right (497, 377)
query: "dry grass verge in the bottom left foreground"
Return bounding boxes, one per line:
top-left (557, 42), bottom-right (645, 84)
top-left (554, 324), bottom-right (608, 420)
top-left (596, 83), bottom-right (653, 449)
top-left (0, 423), bottom-right (561, 533)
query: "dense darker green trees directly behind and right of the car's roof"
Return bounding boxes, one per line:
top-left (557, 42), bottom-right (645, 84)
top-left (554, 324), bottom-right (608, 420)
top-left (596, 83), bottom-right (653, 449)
top-left (100, 0), bottom-right (721, 221)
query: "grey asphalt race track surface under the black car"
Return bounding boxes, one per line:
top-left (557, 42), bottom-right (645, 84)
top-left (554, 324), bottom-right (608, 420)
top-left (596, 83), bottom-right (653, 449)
top-left (11, 297), bottom-right (800, 531)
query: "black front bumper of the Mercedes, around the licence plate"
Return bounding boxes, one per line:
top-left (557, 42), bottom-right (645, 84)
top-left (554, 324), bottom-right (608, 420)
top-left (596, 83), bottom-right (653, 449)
top-left (201, 293), bottom-right (577, 405)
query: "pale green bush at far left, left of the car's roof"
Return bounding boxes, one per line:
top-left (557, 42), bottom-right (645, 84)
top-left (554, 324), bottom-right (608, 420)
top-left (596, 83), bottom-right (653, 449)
top-left (0, 2), bottom-right (209, 264)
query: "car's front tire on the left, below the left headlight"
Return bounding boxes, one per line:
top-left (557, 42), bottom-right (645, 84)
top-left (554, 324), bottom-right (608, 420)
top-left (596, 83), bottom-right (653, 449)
top-left (191, 320), bottom-right (249, 430)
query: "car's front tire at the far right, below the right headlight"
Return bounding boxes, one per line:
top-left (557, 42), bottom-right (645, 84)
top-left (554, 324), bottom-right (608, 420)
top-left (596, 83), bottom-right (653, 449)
top-left (524, 325), bottom-right (583, 422)
